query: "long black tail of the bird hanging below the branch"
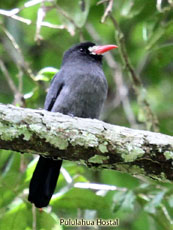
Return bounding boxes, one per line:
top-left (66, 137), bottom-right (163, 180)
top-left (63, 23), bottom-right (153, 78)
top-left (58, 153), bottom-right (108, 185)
top-left (28, 156), bottom-right (62, 208)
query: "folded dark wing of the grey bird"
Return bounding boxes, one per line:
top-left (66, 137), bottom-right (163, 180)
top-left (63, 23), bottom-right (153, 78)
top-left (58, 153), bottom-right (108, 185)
top-left (44, 71), bottom-right (64, 111)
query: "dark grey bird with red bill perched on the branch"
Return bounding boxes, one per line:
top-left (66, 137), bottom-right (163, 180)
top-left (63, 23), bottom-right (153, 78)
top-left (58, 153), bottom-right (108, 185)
top-left (28, 41), bottom-right (118, 208)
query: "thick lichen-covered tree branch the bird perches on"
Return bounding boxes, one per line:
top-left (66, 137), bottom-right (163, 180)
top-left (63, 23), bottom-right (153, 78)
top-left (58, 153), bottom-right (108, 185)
top-left (0, 104), bottom-right (173, 181)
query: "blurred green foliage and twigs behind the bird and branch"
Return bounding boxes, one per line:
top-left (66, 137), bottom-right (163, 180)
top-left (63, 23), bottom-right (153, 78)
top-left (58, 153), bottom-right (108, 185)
top-left (0, 0), bottom-right (173, 230)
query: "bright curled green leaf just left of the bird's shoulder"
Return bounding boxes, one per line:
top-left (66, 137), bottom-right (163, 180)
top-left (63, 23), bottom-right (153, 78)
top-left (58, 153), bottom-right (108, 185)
top-left (35, 67), bottom-right (58, 81)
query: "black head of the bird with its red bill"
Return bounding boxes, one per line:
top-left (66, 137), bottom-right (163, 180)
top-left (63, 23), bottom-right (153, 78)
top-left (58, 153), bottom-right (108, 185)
top-left (63, 42), bottom-right (118, 64)
